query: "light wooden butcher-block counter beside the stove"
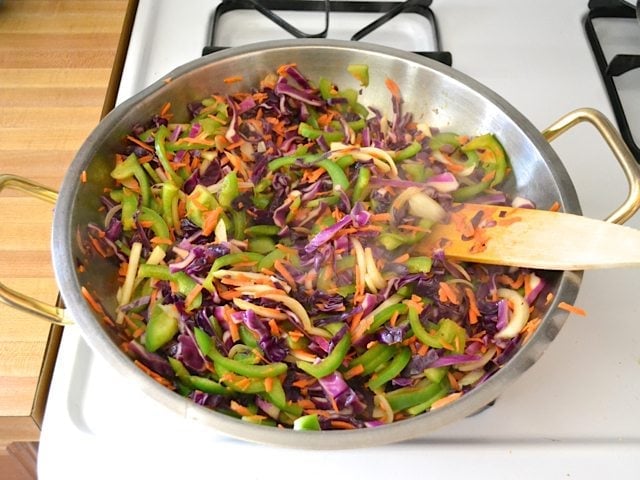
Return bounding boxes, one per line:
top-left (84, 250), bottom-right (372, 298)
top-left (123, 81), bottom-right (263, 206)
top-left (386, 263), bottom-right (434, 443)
top-left (0, 0), bottom-right (128, 478)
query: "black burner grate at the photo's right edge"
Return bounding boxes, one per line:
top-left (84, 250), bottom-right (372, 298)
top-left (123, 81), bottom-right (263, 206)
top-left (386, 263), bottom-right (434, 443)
top-left (584, 0), bottom-right (640, 162)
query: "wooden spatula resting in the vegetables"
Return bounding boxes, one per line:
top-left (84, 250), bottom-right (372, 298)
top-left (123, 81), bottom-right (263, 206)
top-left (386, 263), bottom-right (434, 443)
top-left (418, 204), bottom-right (640, 270)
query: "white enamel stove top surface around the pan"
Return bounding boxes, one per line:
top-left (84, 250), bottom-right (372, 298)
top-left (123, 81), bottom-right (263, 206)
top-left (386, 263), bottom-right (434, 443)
top-left (38, 0), bottom-right (640, 480)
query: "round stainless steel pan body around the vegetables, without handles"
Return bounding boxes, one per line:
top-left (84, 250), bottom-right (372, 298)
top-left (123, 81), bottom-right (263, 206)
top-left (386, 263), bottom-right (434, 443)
top-left (53, 40), bottom-right (580, 448)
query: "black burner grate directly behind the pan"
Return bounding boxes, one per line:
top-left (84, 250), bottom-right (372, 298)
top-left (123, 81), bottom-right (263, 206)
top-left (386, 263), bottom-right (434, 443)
top-left (202, 0), bottom-right (452, 66)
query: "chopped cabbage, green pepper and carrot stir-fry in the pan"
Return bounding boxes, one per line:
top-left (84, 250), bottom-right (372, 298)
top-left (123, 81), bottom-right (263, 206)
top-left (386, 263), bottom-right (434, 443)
top-left (84, 64), bottom-right (545, 430)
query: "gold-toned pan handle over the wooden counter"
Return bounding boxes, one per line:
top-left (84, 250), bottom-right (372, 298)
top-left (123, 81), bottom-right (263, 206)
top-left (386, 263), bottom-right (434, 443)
top-left (0, 175), bottom-right (72, 325)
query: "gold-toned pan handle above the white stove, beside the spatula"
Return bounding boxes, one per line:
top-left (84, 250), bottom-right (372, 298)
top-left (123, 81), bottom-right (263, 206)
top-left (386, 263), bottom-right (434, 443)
top-left (542, 108), bottom-right (640, 224)
